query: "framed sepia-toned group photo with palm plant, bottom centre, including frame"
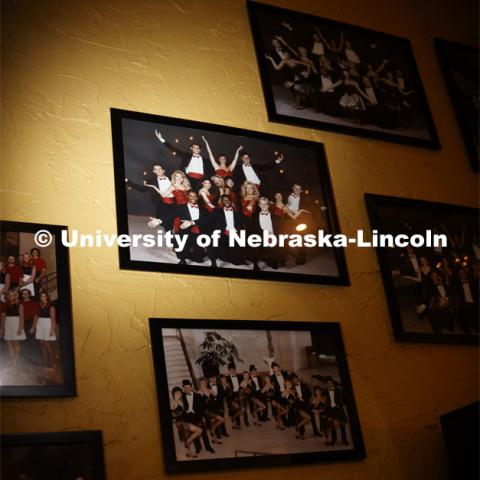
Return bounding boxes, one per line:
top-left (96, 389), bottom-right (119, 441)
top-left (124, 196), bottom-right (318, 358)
top-left (150, 318), bottom-right (365, 473)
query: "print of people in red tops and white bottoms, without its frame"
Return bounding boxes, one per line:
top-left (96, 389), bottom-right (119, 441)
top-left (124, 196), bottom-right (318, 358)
top-left (0, 229), bottom-right (63, 386)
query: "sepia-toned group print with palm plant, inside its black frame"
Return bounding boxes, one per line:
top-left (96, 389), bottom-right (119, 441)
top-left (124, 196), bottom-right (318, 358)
top-left (162, 328), bottom-right (355, 462)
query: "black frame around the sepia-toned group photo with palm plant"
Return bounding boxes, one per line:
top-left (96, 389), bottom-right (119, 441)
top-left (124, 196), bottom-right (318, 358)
top-left (149, 318), bottom-right (366, 473)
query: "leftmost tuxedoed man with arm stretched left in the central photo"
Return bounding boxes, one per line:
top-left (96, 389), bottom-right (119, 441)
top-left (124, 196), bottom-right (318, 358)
top-left (125, 163), bottom-right (175, 231)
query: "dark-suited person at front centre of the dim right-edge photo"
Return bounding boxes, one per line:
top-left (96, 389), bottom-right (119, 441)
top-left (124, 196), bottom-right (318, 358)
top-left (417, 270), bottom-right (455, 334)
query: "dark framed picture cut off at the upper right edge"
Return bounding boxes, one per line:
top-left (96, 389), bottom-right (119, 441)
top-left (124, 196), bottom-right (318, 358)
top-left (435, 38), bottom-right (480, 171)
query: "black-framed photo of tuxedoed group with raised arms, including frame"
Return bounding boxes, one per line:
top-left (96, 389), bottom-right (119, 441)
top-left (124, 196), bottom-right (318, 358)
top-left (111, 109), bottom-right (349, 285)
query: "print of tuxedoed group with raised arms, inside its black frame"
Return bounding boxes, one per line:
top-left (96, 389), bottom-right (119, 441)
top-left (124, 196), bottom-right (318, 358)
top-left (121, 119), bottom-right (339, 277)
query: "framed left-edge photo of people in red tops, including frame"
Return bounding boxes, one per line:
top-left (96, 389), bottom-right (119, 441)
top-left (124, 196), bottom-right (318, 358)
top-left (0, 221), bottom-right (76, 397)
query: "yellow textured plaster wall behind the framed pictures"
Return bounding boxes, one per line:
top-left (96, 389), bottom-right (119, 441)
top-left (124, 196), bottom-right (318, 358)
top-left (1, 0), bottom-right (478, 480)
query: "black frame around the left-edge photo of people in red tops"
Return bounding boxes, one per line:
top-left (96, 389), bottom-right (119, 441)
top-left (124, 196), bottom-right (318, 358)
top-left (0, 220), bottom-right (76, 397)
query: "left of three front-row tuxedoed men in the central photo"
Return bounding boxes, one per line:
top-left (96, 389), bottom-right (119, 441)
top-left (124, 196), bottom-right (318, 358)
top-left (173, 190), bottom-right (213, 265)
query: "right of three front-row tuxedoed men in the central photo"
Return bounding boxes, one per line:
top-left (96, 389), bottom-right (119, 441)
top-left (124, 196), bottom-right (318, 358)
top-left (248, 197), bottom-right (285, 270)
